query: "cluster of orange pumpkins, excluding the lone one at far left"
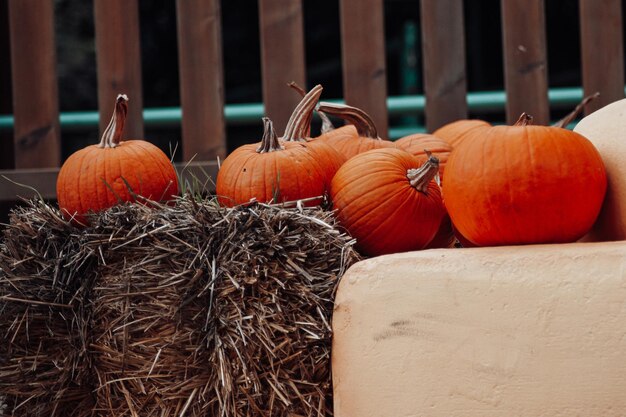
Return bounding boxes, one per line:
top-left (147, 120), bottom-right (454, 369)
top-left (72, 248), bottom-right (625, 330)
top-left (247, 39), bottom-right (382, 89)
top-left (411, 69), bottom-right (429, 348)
top-left (216, 83), bottom-right (607, 256)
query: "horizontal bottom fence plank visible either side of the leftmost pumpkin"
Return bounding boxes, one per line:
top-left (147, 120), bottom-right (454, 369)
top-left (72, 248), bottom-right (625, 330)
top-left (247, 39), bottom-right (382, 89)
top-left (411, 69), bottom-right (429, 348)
top-left (0, 161), bottom-right (217, 201)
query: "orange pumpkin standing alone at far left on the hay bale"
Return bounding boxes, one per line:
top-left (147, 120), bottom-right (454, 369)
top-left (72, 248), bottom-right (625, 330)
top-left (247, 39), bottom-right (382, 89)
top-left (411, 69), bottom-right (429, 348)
top-left (57, 94), bottom-right (178, 225)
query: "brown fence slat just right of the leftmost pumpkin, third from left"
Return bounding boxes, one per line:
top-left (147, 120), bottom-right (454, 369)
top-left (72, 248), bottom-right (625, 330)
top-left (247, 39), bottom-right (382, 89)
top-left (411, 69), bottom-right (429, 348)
top-left (177, 0), bottom-right (226, 161)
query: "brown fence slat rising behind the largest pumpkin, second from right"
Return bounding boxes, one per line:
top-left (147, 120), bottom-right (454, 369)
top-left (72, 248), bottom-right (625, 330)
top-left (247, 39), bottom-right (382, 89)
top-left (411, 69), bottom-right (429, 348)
top-left (501, 0), bottom-right (550, 124)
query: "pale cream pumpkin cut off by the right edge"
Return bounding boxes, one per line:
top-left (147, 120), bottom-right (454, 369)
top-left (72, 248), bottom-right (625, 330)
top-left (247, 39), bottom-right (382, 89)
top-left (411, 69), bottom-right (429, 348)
top-left (574, 99), bottom-right (626, 242)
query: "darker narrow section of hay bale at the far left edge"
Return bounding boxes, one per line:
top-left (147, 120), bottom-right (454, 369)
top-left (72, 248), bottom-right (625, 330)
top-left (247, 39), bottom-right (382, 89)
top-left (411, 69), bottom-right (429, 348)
top-left (0, 201), bottom-right (94, 416)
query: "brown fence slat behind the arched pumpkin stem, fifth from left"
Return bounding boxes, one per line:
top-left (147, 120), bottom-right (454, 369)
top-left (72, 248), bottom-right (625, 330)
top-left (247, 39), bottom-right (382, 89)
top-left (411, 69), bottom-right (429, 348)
top-left (340, 0), bottom-right (388, 137)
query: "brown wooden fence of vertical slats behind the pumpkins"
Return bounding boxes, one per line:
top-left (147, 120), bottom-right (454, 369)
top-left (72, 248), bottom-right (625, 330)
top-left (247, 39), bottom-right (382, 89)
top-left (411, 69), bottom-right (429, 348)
top-left (0, 0), bottom-right (624, 201)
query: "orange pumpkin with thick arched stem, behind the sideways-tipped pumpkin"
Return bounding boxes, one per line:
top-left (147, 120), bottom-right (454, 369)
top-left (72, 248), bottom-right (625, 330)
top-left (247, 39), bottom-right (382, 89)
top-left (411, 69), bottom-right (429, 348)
top-left (318, 102), bottom-right (395, 159)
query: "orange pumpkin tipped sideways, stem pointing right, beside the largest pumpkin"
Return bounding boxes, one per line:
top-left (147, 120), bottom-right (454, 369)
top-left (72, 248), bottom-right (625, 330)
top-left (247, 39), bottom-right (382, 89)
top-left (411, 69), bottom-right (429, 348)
top-left (331, 148), bottom-right (445, 256)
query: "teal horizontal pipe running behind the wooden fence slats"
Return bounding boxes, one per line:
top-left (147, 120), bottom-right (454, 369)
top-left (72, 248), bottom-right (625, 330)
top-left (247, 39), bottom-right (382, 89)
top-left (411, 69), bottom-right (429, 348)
top-left (0, 87), bottom-right (583, 130)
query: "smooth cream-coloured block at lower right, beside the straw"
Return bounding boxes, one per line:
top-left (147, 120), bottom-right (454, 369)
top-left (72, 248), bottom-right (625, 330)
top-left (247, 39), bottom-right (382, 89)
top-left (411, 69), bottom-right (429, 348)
top-left (332, 242), bottom-right (626, 417)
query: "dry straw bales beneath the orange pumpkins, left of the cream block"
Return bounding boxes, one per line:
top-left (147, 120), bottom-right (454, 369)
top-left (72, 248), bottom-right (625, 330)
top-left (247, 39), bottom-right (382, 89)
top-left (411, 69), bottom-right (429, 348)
top-left (0, 198), bottom-right (358, 417)
